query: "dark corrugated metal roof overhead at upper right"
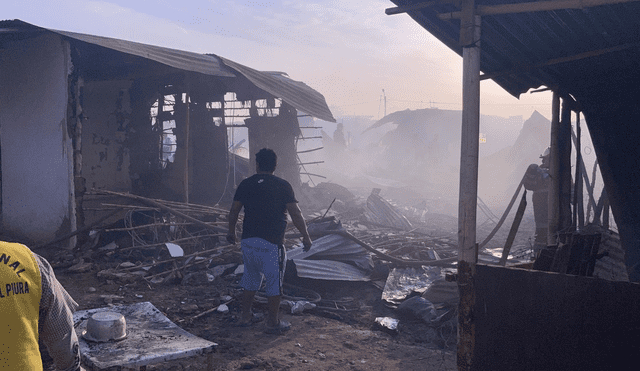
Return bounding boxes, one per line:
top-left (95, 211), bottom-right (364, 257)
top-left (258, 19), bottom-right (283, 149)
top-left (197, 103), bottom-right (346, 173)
top-left (391, 0), bottom-right (640, 97)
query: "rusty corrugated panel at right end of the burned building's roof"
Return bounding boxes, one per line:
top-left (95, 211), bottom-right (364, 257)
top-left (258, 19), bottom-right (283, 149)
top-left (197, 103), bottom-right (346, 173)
top-left (218, 57), bottom-right (336, 122)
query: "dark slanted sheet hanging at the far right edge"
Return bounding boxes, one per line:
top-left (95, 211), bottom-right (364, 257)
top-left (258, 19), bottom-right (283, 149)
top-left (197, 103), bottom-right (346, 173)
top-left (576, 83), bottom-right (640, 282)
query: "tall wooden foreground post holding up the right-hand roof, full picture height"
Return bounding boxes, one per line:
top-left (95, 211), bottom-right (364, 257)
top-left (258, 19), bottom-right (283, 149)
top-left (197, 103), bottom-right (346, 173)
top-left (457, 0), bottom-right (481, 370)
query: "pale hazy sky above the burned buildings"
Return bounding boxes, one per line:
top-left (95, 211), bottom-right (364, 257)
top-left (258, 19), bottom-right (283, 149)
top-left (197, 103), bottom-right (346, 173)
top-left (2, 0), bottom-right (551, 120)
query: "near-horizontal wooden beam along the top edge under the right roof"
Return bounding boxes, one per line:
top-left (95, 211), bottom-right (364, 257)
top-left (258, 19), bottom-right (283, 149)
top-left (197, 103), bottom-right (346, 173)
top-left (438, 0), bottom-right (640, 21)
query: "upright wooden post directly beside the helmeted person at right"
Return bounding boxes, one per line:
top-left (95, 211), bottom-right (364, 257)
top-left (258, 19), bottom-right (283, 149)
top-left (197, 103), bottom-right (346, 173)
top-left (547, 91), bottom-right (560, 245)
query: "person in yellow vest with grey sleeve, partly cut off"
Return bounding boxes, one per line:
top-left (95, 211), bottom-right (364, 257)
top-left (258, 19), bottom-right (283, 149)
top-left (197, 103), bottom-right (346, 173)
top-left (0, 241), bottom-right (83, 371)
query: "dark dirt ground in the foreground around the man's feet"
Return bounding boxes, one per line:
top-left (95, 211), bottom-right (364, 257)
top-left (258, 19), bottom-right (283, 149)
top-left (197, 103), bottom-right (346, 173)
top-left (40, 247), bottom-right (456, 371)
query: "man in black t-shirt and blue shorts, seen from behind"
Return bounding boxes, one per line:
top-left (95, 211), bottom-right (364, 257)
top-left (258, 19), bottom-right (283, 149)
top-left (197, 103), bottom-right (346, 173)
top-left (227, 148), bottom-right (311, 334)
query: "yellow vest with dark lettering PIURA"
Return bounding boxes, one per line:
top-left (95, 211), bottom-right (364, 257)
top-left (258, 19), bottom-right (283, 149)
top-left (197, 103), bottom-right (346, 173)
top-left (0, 241), bottom-right (42, 371)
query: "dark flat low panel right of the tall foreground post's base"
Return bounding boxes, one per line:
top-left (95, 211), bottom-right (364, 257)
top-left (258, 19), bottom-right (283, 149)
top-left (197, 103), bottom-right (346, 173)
top-left (473, 265), bottom-right (640, 371)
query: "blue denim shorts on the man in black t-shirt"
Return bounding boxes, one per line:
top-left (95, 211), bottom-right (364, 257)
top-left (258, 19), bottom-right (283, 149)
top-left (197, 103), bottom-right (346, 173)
top-left (240, 237), bottom-right (287, 296)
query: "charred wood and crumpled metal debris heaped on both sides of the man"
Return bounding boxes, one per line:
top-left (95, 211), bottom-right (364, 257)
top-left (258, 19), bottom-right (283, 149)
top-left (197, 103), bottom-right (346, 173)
top-left (46, 184), bottom-right (500, 341)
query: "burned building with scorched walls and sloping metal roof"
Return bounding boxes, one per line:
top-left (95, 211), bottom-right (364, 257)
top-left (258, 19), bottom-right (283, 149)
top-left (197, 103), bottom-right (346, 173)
top-left (0, 20), bottom-right (335, 245)
